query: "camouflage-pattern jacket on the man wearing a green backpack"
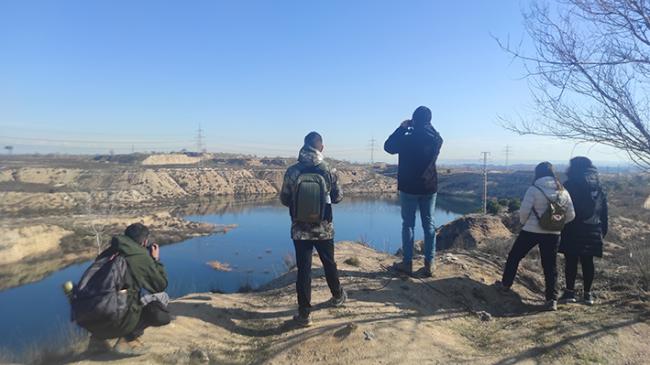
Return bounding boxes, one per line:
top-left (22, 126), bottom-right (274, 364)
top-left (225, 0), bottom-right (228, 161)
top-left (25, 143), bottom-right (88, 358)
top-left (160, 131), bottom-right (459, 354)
top-left (280, 146), bottom-right (343, 241)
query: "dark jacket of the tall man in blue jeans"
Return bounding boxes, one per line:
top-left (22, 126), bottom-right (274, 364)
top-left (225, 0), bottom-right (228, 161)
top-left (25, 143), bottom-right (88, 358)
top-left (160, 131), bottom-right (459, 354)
top-left (384, 123), bottom-right (442, 194)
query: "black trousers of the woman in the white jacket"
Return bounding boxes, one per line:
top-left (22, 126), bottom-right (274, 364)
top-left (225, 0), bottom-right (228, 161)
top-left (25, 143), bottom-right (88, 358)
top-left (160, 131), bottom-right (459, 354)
top-left (501, 231), bottom-right (560, 300)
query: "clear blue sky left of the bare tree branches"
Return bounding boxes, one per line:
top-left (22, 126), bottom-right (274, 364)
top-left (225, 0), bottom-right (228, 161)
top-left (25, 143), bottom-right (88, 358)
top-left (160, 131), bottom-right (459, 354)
top-left (0, 0), bottom-right (624, 163)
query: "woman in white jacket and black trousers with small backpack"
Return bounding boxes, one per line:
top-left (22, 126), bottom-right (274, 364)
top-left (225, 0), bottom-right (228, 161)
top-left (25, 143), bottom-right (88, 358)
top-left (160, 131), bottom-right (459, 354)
top-left (497, 162), bottom-right (575, 310)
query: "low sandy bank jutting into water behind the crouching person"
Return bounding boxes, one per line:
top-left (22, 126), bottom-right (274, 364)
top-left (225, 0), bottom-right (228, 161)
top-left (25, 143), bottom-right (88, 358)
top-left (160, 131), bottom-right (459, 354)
top-left (0, 211), bottom-right (218, 290)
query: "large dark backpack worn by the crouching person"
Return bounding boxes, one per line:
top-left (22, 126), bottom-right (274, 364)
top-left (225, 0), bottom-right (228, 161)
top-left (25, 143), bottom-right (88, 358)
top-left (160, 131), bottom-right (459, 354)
top-left (70, 254), bottom-right (129, 338)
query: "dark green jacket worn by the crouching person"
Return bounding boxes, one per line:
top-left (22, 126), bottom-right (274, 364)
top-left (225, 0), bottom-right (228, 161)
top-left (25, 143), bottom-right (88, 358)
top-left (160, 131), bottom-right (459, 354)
top-left (102, 235), bottom-right (167, 335)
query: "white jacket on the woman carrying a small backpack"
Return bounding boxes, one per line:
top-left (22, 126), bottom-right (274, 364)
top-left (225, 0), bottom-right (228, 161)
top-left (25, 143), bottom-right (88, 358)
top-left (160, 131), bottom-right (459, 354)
top-left (519, 176), bottom-right (575, 235)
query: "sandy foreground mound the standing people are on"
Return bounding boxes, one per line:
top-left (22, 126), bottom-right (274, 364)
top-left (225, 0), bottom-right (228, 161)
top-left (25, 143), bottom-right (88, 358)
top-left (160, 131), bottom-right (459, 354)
top-left (66, 243), bottom-right (650, 364)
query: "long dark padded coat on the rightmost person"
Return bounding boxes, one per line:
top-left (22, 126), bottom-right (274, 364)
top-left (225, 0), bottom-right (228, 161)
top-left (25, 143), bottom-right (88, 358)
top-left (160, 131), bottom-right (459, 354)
top-left (560, 168), bottom-right (608, 257)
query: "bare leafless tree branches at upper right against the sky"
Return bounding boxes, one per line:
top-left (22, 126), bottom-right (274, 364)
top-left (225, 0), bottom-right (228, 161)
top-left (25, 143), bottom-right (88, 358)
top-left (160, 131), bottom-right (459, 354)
top-left (497, 0), bottom-right (650, 170)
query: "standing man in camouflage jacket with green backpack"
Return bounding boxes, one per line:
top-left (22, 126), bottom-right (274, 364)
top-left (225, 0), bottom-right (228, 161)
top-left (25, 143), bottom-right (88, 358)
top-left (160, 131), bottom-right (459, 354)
top-left (280, 132), bottom-right (347, 327)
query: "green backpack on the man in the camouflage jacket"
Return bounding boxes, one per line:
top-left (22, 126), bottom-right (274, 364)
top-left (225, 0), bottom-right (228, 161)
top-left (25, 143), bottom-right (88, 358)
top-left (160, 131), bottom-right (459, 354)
top-left (293, 173), bottom-right (328, 223)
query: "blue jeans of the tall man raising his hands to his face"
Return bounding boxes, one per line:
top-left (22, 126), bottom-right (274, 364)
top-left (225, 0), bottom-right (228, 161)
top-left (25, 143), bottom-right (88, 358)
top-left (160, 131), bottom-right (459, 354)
top-left (399, 191), bottom-right (437, 262)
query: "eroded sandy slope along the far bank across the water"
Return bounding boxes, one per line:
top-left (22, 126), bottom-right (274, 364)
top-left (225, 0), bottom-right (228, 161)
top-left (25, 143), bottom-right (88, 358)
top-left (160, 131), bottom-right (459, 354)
top-left (0, 165), bottom-right (396, 216)
